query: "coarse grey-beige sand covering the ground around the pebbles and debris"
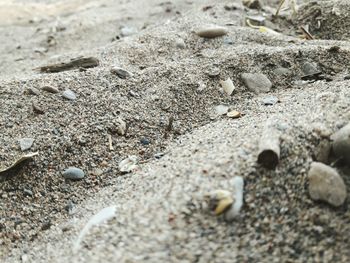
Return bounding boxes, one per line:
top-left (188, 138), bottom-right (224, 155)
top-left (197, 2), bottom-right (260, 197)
top-left (0, 0), bottom-right (350, 262)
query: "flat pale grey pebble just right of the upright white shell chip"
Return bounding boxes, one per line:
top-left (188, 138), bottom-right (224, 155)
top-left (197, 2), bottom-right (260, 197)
top-left (242, 73), bottom-right (272, 93)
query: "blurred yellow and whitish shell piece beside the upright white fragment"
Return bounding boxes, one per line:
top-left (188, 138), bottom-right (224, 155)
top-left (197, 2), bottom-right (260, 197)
top-left (206, 189), bottom-right (233, 215)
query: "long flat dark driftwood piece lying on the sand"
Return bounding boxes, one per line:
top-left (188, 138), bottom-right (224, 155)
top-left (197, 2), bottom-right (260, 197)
top-left (38, 57), bottom-right (100, 73)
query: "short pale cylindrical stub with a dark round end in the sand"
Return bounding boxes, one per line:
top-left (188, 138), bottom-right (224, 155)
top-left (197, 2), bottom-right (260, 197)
top-left (258, 125), bottom-right (280, 169)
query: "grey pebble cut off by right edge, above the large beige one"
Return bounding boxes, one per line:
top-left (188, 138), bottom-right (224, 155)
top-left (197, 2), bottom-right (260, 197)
top-left (331, 123), bottom-right (350, 166)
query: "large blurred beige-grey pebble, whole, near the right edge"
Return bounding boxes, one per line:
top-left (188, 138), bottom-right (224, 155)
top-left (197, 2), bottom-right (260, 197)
top-left (308, 162), bottom-right (346, 206)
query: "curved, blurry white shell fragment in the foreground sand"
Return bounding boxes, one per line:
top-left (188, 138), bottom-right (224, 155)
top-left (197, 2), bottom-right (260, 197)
top-left (73, 206), bottom-right (117, 251)
